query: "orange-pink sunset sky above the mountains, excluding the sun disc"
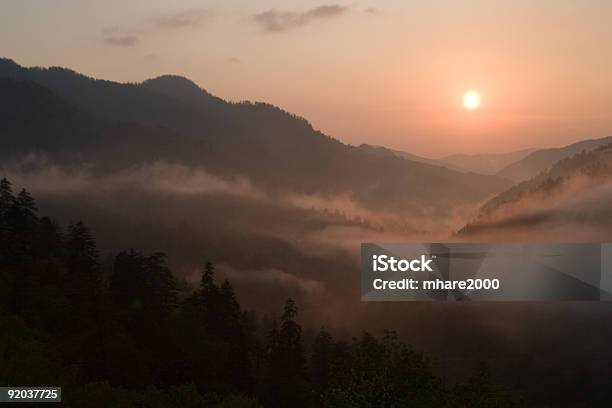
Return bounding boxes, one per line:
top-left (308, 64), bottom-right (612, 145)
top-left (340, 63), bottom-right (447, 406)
top-left (0, 0), bottom-right (612, 158)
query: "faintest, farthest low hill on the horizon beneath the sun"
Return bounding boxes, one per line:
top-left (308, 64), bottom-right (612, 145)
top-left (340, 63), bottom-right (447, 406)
top-left (437, 149), bottom-right (537, 174)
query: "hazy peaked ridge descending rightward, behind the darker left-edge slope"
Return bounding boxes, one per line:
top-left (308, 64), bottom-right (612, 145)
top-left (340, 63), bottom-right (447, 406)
top-left (0, 62), bottom-right (508, 214)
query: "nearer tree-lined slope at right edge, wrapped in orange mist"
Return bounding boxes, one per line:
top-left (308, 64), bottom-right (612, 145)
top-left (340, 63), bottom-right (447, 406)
top-left (459, 141), bottom-right (612, 237)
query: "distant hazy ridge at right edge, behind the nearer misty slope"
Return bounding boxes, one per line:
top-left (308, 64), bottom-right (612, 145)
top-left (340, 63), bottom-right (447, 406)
top-left (497, 136), bottom-right (612, 181)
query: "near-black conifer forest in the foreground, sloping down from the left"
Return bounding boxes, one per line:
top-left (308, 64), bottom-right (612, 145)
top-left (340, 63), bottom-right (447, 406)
top-left (0, 179), bottom-right (518, 408)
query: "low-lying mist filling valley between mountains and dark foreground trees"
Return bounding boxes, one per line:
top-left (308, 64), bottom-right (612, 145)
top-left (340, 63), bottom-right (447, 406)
top-left (1, 159), bottom-right (612, 396)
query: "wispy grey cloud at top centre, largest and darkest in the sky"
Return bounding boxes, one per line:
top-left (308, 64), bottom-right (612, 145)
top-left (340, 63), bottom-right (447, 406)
top-left (252, 4), bottom-right (348, 33)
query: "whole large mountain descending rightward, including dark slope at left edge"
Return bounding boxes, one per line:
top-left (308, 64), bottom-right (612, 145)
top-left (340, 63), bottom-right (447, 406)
top-left (0, 59), bottom-right (508, 215)
